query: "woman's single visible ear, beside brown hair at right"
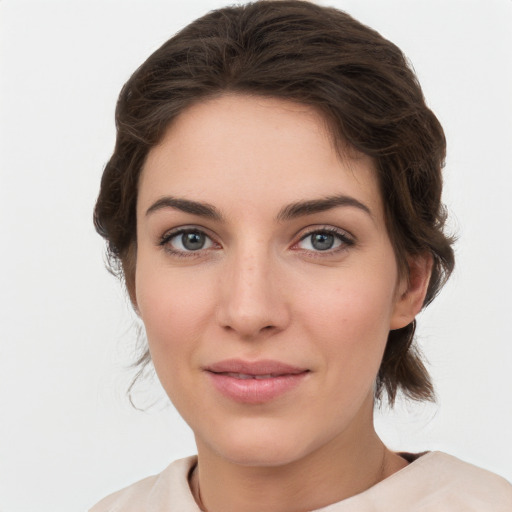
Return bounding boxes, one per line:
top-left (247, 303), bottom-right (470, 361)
top-left (390, 252), bottom-right (433, 330)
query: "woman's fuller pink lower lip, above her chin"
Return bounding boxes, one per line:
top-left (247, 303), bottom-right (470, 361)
top-left (207, 372), bottom-right (308, 404)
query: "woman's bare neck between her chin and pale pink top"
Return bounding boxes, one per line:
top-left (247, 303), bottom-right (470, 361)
top-left (191, 404), bottom-right (407, 512)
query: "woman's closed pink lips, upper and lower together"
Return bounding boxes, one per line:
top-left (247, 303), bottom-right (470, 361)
top-left (204, 359), bottom-right (309, 404)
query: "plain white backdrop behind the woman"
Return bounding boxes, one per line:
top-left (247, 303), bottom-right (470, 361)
top-left (0, 0), bottom-right (512, 512)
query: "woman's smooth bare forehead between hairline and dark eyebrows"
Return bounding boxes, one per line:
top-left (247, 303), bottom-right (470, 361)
top-left (138, 95), bottom-right (382, 222)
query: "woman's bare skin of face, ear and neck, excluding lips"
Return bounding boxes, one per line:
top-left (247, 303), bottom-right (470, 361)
top-left (132, 95), bottom-right (430, 512)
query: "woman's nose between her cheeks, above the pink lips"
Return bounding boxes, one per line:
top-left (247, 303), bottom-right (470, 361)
top-left (217, 245), bottom-right (290, 339)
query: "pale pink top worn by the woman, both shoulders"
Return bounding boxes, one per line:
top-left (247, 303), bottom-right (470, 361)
top-left (90, 452), bottom-right (512, 512)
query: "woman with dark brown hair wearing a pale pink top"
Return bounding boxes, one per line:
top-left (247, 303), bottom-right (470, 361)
top-left (92, 1), bottom-right (512, 512)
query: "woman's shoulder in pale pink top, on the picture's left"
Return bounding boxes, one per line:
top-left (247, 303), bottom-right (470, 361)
top-left (89, 457), bottom-right (199, 512)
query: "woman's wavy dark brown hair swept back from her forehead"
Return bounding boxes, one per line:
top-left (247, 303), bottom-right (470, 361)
top-left (94, 0), bottom-right (454, 404)
